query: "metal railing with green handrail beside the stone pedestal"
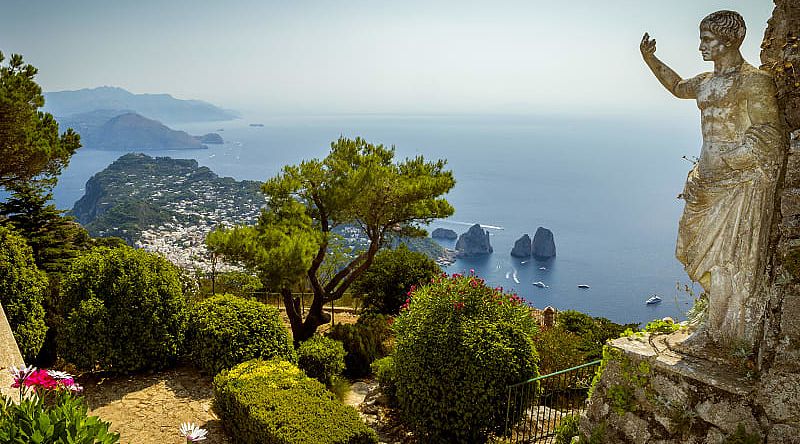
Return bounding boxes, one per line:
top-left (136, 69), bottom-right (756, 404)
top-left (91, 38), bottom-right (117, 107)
top-left (504, 361), bottom-right (600, 444)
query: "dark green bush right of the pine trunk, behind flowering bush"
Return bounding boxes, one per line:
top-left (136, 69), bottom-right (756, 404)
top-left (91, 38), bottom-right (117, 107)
top-left (353, 245), bottom-right (442, 315)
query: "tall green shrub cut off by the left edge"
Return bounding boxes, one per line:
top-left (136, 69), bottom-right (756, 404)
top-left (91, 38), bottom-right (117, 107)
top-left (0, 227), bottom-right (48, 361)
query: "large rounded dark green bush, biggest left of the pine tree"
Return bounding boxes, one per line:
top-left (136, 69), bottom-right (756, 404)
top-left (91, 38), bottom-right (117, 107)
top-left (59, 247), bottom-right (186, 372)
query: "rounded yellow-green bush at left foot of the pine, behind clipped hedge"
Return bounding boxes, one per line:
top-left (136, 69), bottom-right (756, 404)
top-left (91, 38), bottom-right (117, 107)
top-left (186, 295), bottom-right (297, 374)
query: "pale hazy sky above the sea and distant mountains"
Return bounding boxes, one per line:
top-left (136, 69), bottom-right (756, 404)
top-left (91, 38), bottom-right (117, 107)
top-left (0, 0), bottom-right (773, 115)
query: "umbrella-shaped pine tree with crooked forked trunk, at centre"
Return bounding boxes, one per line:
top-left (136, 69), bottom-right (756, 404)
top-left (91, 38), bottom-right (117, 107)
top-left (206, 138), bottom-right (455, 342)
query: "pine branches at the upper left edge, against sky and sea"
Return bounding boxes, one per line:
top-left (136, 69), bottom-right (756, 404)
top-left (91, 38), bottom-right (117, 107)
top-left (0, 53), bottom-right (80, 188)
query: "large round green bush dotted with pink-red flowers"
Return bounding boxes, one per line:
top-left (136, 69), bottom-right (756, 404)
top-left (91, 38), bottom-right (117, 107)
top-left (393, 274), bottom-right (538, 443)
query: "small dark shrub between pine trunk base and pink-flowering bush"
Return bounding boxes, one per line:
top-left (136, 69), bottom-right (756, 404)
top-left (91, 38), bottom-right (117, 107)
top-left (328, 314), bottom-right (391, 378)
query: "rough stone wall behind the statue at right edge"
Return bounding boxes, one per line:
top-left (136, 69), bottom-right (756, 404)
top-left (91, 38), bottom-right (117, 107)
top-left (759, 0), bottom-right (800, 373)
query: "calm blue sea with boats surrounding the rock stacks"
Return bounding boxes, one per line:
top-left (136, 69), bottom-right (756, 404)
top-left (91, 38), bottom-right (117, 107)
top-left (55, 112), bottom-right (700, 322)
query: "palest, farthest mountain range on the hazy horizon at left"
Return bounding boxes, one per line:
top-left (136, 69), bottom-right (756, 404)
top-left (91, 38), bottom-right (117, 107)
top-left (44, 86), bottom-right (239, 123)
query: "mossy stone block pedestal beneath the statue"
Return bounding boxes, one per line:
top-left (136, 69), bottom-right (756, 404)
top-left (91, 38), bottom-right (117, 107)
top-left (581, 333), bottom-right (800, 444)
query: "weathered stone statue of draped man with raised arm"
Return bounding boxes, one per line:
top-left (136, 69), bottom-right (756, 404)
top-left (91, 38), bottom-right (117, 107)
top-left (640, 11), bottom-right (785, 346)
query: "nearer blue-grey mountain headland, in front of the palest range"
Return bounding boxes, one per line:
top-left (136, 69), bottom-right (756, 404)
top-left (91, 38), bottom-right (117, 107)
top-left (78, 111), bottom-right (208, 151)
